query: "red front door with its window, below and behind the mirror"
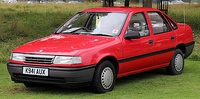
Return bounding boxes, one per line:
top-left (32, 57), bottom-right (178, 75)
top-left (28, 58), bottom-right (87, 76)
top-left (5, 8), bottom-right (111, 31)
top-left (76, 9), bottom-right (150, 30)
top-left (121, 13), bottom-right (154, 74)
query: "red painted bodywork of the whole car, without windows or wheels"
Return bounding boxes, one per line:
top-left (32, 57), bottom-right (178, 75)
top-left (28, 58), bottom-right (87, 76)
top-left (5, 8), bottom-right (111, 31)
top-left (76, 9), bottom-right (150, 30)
top-left (7, 7), bottom-right (194, 87)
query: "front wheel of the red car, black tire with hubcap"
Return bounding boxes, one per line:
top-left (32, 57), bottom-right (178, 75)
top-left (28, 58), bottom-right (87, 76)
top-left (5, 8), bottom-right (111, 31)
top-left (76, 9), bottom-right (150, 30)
top-left (91, 61), bottom-right (116, 93)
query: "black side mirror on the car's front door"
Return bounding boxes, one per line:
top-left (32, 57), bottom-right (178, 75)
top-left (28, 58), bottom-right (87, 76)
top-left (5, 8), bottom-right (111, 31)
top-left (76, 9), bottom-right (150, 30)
top-left (124, 31), bottom-right (140, 39)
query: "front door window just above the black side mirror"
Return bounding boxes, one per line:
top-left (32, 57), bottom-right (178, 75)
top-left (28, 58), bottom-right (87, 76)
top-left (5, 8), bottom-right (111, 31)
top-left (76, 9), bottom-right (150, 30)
top-left (128, 13), bottom-right (149, 36)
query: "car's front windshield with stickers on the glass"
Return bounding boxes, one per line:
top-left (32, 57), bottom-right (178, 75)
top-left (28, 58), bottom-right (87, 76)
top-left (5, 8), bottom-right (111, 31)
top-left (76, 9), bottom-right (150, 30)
top-left (57, 12), bottom-right (127, 36)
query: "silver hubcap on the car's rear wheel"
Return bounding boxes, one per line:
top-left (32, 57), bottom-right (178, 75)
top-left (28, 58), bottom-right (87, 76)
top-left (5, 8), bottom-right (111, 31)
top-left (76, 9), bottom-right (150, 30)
top-left (175, 54), bottom-right (183, 72)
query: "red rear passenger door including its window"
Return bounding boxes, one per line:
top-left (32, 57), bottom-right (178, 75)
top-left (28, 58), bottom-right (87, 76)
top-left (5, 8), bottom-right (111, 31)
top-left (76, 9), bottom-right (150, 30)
top-left (148, 12), bottom-right (176, 67)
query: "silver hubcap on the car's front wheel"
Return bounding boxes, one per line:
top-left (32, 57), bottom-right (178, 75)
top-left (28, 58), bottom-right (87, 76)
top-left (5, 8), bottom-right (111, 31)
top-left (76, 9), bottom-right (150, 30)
top-left (101, 67), bottom-right (113, 89)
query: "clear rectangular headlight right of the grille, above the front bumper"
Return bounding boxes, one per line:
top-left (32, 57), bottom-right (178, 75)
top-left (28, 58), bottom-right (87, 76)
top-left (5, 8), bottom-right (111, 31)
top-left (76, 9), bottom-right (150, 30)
top-left (53, 56), bottom-right (82, 64)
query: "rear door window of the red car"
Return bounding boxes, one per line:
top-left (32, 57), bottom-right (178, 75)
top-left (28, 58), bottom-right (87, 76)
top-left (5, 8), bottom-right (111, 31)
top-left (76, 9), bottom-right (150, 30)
top-left (148, 12), bottom-right (171, 34)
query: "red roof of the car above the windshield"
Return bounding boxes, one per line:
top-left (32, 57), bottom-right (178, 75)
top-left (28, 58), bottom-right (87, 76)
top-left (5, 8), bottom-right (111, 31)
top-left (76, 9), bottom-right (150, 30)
top-left (81, 7), bottom-right (159, 13)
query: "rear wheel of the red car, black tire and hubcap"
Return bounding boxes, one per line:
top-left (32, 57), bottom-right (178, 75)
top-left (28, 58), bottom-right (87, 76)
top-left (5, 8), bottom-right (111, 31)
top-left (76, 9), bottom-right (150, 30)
top-left (167, 49), bottom-right (184, 75)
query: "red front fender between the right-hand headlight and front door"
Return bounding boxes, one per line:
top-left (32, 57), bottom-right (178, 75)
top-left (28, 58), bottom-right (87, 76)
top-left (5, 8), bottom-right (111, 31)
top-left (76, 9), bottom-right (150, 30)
top-left (73, 37), bottom-right (122, 66)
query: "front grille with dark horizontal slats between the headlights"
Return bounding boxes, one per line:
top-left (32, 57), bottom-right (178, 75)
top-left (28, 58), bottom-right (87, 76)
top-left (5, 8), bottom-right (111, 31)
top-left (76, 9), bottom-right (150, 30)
top-left (25, 55), bottom-right (54, 64)
